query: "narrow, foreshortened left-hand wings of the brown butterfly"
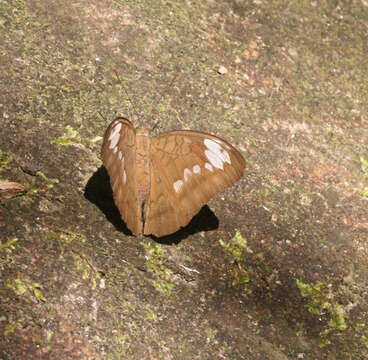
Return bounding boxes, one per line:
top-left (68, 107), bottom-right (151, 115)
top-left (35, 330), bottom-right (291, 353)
top-left (102, 118), bottom-right (142, 234)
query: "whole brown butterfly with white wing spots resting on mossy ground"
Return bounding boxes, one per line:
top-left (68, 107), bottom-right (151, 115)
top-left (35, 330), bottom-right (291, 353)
top-left (102, 118), bottom-right (245, 237)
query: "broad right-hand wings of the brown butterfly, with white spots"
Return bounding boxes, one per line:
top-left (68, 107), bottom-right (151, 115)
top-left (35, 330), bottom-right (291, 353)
top-left (144, 131), bottom-right (245, 237)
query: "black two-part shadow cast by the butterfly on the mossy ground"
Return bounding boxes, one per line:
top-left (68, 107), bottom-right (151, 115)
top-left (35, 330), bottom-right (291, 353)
top-left (84, 166), bottom-right (219, 244)
